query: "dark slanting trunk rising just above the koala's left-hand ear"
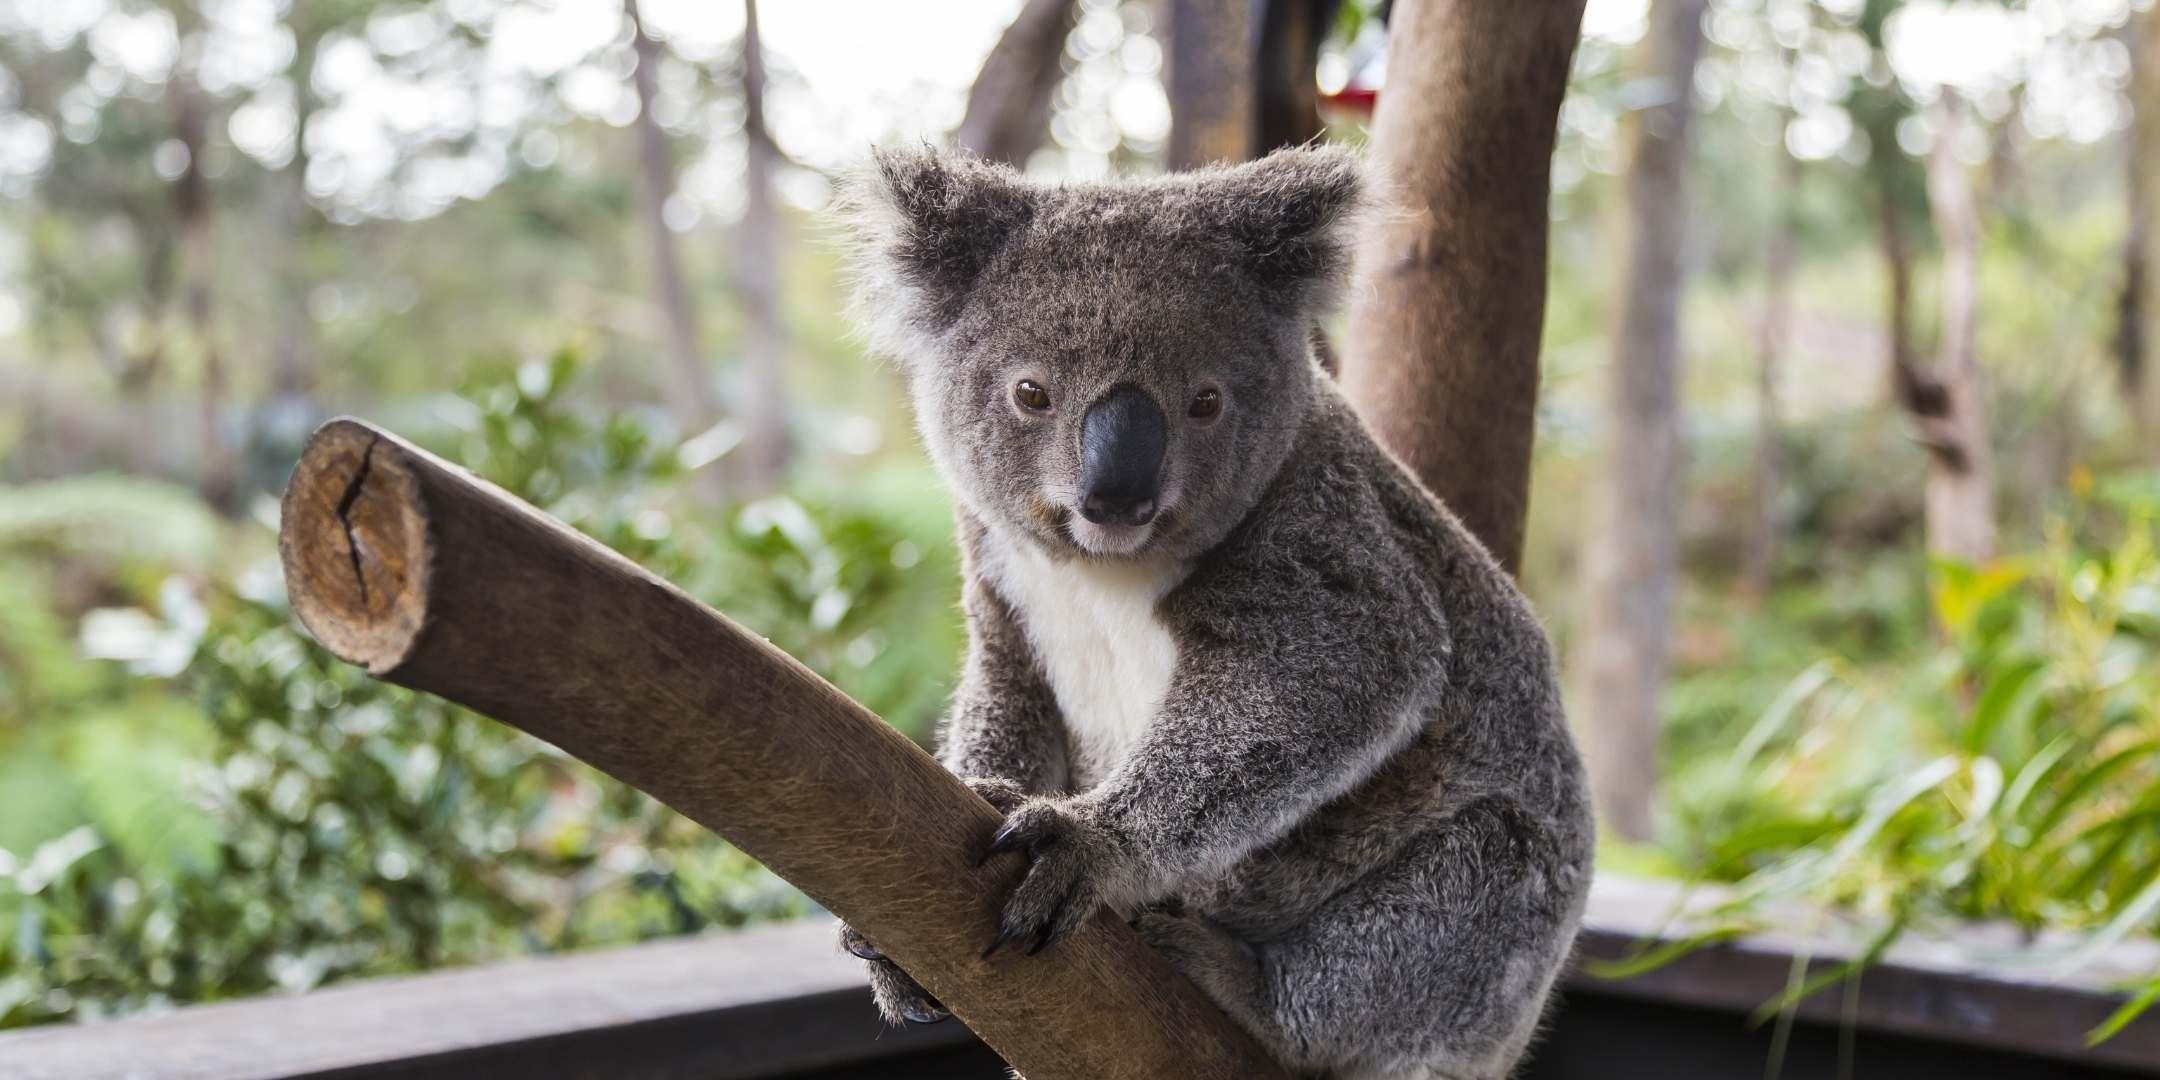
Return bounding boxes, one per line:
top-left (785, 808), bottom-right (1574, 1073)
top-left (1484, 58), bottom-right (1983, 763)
top-left (953, 0), bottom-right (1080, 166)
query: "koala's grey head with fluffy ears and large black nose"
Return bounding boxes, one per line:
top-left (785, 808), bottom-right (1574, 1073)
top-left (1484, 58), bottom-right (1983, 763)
top-left (847, 147), bottom-right (1359, 559)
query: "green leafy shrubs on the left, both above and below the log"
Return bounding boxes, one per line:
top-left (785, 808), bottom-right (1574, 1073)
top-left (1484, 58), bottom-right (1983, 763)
top-left (0, 350), bottom-right (959, 1026)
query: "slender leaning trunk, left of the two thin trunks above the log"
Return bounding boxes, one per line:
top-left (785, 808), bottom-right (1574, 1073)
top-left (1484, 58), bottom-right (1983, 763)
top-left (622, 0), bottom-right (719, 434)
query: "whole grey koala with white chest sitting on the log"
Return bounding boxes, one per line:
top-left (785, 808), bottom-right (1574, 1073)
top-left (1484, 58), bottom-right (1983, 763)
top-left (842, 147), bottom-right (1594, 1080)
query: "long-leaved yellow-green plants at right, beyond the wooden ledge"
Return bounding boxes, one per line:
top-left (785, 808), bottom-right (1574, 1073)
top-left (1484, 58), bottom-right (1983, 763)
top-left (1644, 475), bottom-right (2160, 1030)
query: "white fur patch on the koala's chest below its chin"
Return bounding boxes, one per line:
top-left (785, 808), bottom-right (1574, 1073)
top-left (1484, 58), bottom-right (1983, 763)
top-left (987, 538), bottom-right (1179, 791)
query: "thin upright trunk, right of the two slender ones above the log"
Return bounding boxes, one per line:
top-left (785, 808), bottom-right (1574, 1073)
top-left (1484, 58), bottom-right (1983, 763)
top-left (730, 0), bottom-right (788, 497)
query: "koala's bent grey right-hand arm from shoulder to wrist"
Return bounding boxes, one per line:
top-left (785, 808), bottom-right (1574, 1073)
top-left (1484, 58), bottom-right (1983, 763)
top-left (1076, 540), bottom-right (1449, 903)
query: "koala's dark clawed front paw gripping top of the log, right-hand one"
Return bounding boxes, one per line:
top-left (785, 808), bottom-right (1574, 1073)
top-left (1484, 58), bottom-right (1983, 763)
top-left (983, 799), bottom-right (1123, 957)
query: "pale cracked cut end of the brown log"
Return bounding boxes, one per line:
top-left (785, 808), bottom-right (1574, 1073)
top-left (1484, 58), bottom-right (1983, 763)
top-left (279, 419), bottom-right (430, 676)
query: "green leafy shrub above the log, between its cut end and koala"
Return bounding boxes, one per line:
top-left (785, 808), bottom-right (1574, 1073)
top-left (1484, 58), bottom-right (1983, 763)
top-left (436, 350), bottom-right (963, 739)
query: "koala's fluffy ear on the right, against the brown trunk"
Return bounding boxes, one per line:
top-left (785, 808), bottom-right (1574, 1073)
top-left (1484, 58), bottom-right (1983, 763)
top-left (1210, 147), bottom-right (1365, 305)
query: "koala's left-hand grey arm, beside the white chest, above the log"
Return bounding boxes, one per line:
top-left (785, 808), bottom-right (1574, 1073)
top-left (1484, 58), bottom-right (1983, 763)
top-left (937, 577), bottom-right (1069, 794)
